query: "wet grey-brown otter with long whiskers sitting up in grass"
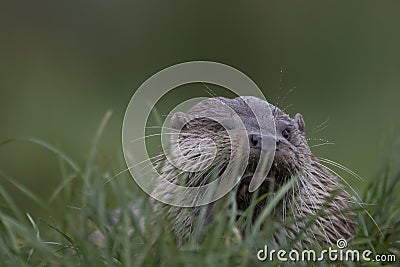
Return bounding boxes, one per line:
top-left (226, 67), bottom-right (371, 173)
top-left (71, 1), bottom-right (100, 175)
top-left (153, 96), bottom-right (354, 246)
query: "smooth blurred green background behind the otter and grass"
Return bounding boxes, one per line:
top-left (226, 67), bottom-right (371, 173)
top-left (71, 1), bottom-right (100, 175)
top-left (0, 0), bottom-right (400, 216)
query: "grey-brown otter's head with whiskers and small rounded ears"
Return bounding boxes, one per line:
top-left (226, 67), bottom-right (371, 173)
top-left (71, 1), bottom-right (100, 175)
top-left (167, 96), bottom-right (311, 205)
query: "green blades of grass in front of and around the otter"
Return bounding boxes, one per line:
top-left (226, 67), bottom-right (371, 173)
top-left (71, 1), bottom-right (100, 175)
top-left (0, 113), bottom-right (400, 266)
